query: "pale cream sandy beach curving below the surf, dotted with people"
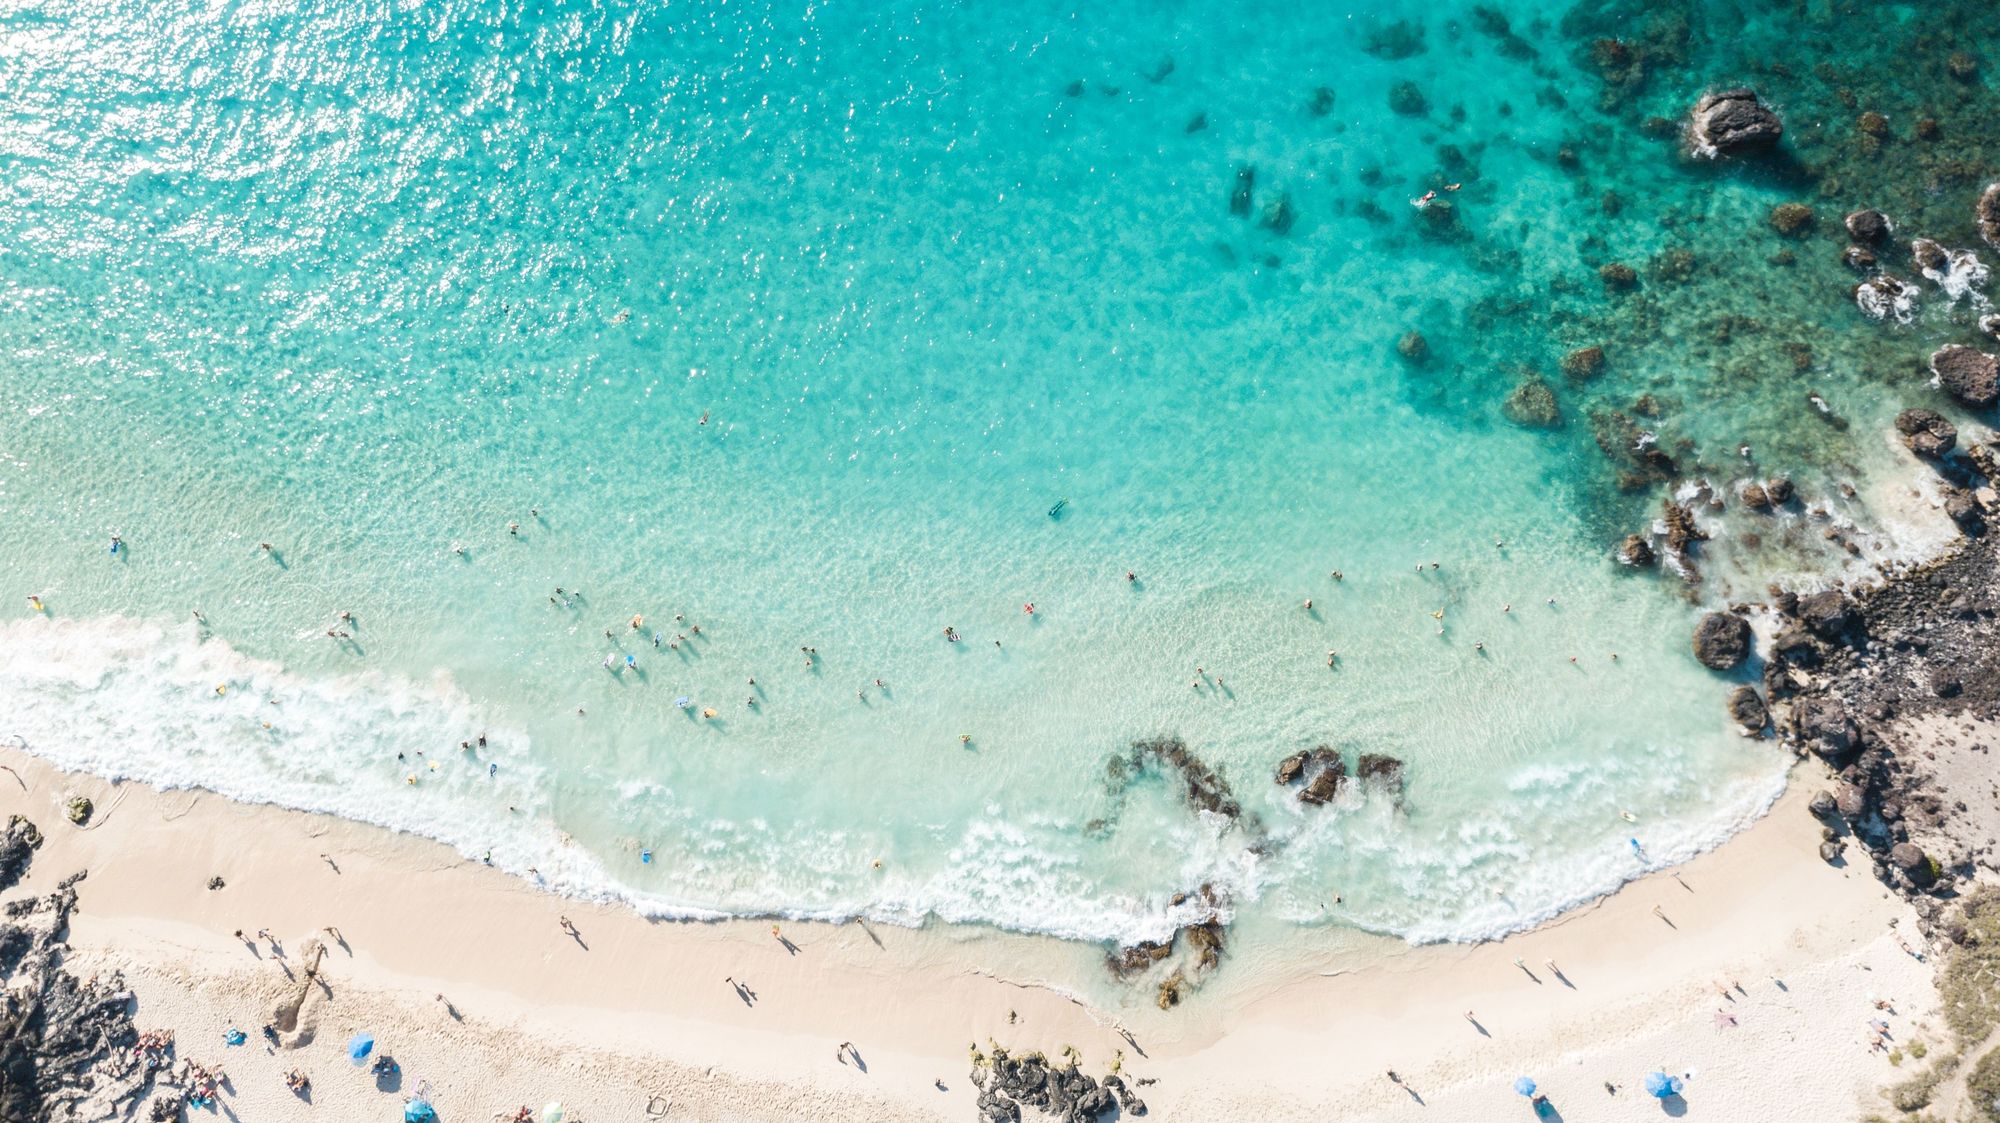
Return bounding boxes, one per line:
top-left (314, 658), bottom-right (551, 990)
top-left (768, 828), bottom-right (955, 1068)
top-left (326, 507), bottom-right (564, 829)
top-left (0, 749), bottom-right (1936, 1121)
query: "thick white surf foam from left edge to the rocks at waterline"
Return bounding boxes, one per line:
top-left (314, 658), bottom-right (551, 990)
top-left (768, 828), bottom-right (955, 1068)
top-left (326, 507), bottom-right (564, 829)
top-left (0, 617), bottom-right (1244, 941)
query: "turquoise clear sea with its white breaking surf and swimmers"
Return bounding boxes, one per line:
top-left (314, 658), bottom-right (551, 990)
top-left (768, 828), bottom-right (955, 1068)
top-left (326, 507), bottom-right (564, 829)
top-left (0, 2), bottom-right (1976, 939)
